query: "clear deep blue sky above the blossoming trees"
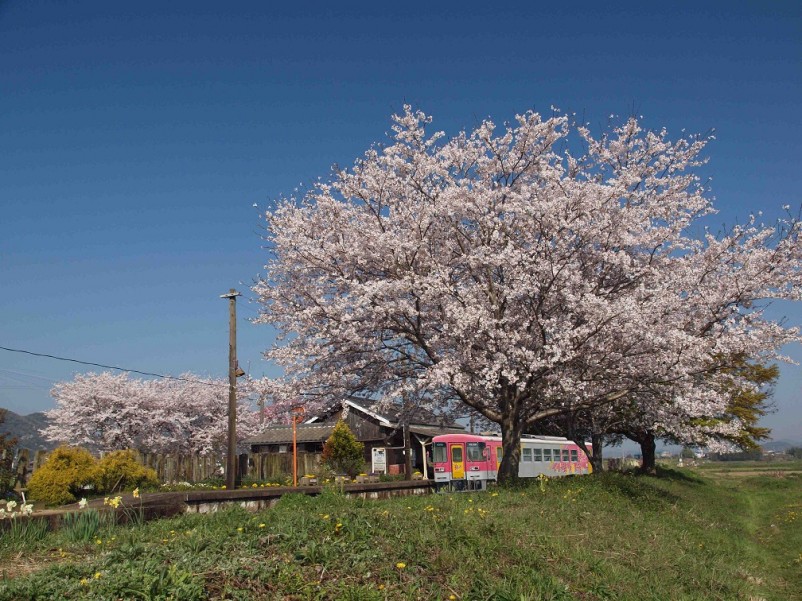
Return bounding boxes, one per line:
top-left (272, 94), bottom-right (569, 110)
top-left (0, 0), bottom-right (802, 441)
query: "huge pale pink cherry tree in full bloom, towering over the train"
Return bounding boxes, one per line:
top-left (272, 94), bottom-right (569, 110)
top-left (254, 107), bottom-right (800, 480)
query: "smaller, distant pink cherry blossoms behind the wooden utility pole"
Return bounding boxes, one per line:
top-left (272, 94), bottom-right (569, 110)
top-left (42, 372), bottom-right (258, 454)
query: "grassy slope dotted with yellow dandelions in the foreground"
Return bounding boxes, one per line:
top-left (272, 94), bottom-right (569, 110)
top-left (0, 471), bottom-right (802, 601)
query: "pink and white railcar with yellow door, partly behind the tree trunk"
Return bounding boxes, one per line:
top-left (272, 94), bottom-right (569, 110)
top-left (432, 434), bottom-right (591, 490)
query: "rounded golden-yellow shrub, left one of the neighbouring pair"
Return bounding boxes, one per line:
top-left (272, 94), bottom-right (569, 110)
top-left (28, 447), bottom-right (96, 505)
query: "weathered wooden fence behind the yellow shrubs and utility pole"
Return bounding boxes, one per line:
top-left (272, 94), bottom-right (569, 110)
top-left (14, 449), bottom-right (320, 488)
